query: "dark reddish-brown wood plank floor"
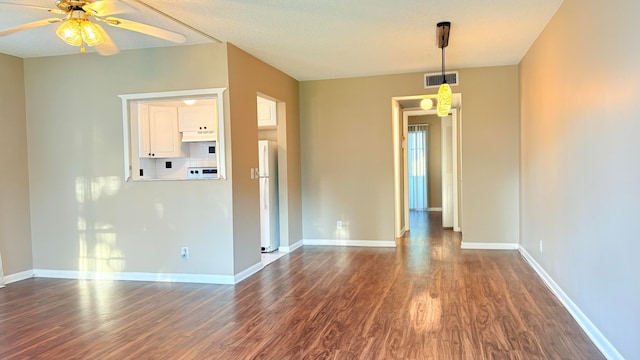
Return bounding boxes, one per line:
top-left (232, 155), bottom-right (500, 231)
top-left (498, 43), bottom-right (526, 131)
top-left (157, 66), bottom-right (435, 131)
top-left (0, 213), bottom-right (603, 360)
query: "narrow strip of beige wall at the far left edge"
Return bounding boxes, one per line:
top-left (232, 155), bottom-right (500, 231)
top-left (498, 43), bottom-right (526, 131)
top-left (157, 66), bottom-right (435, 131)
top-left (0, 54), bottom-right (33, 275)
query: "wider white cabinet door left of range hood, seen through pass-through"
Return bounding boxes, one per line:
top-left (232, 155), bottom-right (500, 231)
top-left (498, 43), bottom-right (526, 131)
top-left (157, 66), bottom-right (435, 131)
top-left (149, 106), bottom-right (180, 158)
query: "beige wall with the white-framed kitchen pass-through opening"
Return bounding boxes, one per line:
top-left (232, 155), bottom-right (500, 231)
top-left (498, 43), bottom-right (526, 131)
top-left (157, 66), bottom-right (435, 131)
top-left (24, 44), bottom-right (238, 275)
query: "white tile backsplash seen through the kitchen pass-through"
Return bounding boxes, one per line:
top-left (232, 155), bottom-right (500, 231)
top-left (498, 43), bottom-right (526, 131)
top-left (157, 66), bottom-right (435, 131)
top-left (140, 141), bottom-right (218, 180)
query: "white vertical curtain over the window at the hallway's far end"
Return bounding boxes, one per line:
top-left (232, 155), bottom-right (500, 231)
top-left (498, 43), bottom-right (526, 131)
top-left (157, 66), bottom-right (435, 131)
top-left (407, 125), bottom-right (428, 210)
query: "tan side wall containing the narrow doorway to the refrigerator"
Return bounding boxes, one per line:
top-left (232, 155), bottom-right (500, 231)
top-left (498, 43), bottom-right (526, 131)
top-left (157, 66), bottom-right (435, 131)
top-left (227, 44), bottom-right (302, 272)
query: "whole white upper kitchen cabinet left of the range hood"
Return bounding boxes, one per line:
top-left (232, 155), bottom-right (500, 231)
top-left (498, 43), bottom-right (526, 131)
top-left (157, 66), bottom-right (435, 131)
top-left (139, 105), bottom-right (184, 158)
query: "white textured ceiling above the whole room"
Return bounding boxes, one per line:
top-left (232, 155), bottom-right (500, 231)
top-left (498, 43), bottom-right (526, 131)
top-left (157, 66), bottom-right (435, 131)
top-left (0, 0), bottom-right (562, 80)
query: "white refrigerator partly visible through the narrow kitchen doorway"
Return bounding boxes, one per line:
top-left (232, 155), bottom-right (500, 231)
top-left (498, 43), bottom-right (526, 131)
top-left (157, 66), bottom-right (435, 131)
top-left (258, 140), bottom-right (280, 252)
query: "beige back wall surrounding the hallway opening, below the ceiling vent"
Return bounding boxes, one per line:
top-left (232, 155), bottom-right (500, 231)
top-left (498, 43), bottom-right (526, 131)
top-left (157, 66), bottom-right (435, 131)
top-left (300, 66), bottom-right (519, 243)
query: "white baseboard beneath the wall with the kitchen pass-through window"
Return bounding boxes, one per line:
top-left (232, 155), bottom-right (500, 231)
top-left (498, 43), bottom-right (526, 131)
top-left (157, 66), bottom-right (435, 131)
top-left (33, 269), bottom-right (235, 285)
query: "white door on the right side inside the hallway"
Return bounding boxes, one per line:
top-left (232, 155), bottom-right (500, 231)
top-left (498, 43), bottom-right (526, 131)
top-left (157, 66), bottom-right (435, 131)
top-left (441, 115), bottom-right (454, 227)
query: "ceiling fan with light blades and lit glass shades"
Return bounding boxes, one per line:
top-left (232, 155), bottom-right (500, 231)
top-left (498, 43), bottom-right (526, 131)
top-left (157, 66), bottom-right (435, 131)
top-left (0, 0), bottom-right (186, 55)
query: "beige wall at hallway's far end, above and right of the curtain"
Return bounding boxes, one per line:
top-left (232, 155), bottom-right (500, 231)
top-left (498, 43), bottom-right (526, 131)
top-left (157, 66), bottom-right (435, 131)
top-left (409, 115), bottom-right (442, 208)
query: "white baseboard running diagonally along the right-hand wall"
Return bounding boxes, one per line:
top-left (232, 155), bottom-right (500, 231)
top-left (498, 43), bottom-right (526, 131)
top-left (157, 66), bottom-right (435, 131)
top-left (519, 247), bottom-right (624, 360)
